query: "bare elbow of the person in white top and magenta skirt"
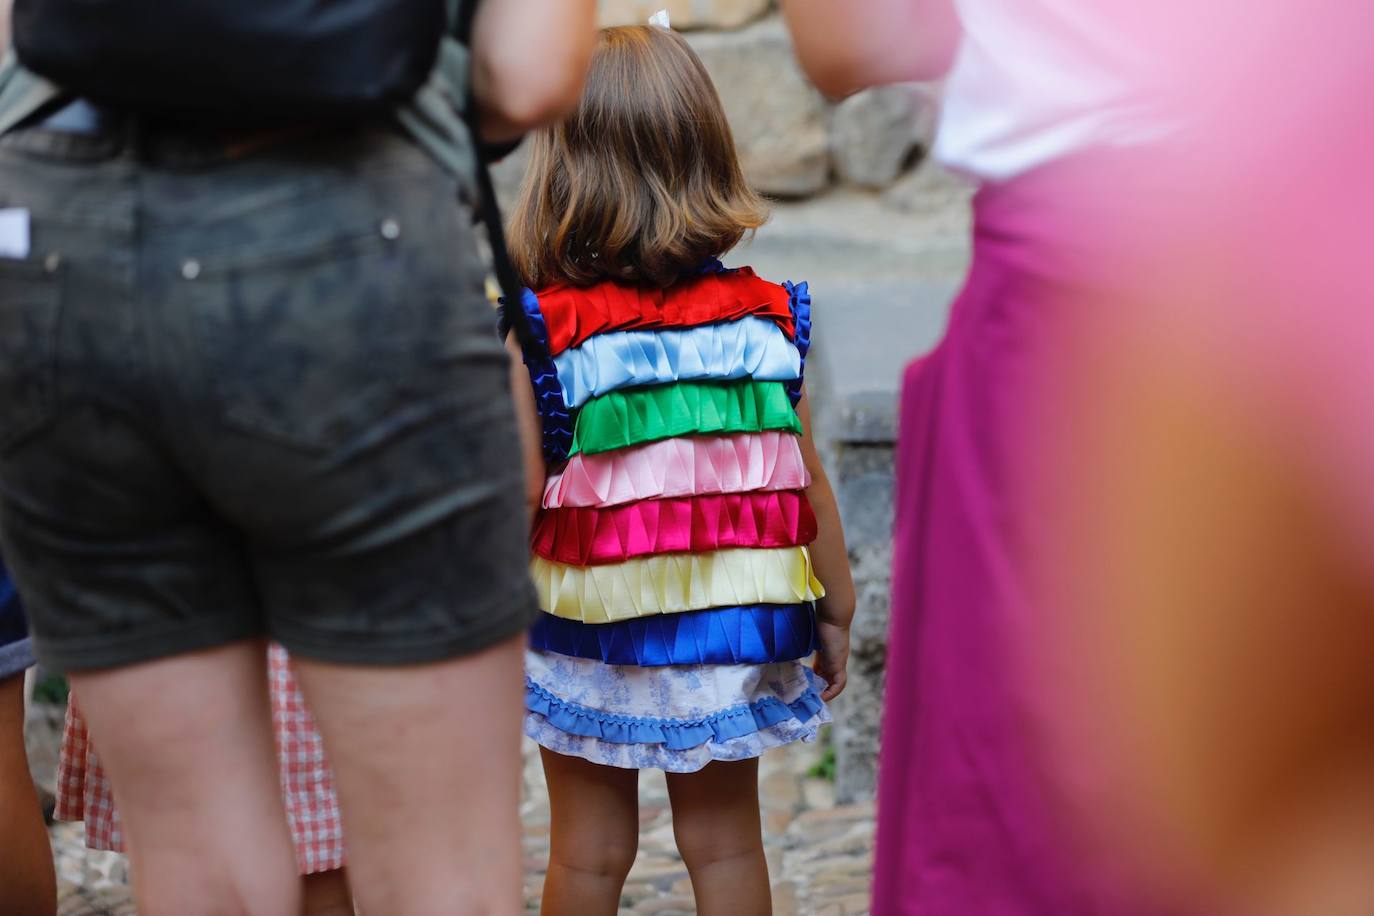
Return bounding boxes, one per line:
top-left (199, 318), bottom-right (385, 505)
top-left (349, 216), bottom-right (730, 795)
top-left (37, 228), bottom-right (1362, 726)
top-left (782, 0), bottom-right (960, 98)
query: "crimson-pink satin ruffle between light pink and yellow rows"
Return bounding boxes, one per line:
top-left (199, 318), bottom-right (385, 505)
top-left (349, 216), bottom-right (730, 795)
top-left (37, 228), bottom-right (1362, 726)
top-left (530, 490), bottom-right (816, 566)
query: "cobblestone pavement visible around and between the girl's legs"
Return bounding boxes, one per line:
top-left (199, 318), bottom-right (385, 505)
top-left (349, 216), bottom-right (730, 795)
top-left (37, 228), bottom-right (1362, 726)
top-left (52, 744), bottom-right (874, 916)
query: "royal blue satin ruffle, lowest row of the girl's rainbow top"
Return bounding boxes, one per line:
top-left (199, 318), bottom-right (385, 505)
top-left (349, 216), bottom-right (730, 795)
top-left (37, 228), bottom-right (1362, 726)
top-left (529, 604), bottom-right (816, 667)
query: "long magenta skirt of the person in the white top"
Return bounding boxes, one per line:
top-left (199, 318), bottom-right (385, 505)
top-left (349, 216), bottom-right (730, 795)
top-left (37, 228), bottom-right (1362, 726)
top-left (872, 162), bottom-right (1167, 916)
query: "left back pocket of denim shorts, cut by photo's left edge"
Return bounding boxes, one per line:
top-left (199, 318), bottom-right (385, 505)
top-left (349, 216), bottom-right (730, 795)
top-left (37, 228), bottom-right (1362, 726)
top-left (0, 257), bottom-right (62, 450)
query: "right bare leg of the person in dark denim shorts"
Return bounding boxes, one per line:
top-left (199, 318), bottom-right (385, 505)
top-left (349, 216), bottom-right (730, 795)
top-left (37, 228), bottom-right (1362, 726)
top-left (293, 637), bottom-right (525, 916)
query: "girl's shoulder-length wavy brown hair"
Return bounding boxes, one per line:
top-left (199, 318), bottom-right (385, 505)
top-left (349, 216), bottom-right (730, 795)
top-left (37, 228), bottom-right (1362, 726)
top-left (510, 26), bottom-right (768, 287)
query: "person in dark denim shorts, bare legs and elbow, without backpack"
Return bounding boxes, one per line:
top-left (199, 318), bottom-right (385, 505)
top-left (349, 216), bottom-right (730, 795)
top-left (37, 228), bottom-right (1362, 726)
top-left (0, 0), bottom-right (595, 916)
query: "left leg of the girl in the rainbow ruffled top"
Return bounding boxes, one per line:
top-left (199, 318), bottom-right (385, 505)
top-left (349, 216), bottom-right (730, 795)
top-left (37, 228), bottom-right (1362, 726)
top-left (540, 748), bottom-right (639, 916)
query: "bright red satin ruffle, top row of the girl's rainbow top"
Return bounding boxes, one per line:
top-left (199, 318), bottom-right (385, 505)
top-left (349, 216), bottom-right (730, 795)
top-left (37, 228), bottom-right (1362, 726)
top-left (539, 268), bottom-right (796, 356)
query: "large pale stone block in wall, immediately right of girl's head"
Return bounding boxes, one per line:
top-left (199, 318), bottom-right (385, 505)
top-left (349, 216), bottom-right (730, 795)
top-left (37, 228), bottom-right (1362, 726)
top-left (688, 16), bottom-right (830, 198)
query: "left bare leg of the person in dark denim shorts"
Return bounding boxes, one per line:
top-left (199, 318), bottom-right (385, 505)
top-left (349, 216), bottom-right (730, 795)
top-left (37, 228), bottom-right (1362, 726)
top-left (71, 641), bottom-right (301, 916)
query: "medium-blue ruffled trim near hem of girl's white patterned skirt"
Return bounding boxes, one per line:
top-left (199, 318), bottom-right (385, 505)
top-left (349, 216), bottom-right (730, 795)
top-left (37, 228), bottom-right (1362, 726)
top-left (525, 672), bottom-right (826, 751)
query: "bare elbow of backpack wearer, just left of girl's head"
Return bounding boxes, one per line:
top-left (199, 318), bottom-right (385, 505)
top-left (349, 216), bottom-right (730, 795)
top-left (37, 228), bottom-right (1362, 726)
top-left (473, 0), bottom-right (596, 143)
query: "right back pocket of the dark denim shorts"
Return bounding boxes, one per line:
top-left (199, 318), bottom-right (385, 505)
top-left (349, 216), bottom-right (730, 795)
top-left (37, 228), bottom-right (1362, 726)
top-left (183, 225), bottom-right (442, 452)
